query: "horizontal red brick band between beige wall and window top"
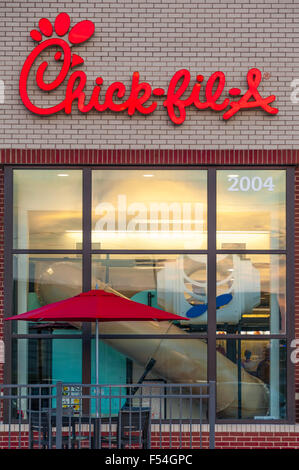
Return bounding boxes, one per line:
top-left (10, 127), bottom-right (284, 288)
top-left (0, 149), bottom-right (299, 165)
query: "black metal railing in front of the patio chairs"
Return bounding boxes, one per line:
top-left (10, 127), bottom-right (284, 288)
top-left (0, 382), bottom-right (216, 449)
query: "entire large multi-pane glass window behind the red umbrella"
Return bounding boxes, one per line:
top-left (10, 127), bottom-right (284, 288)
top-left (5, 167), bottom-right (293, 422)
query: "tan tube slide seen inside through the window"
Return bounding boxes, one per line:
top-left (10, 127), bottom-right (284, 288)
top-left (37, 261), bottom-right (269, 418)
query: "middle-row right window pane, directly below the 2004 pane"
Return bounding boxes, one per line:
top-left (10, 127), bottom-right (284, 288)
top-left (217, 254), bottom-right (286, 334)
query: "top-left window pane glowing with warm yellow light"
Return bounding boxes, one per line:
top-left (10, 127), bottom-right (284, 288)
top-left (13, 170), bottom-right (82, 250)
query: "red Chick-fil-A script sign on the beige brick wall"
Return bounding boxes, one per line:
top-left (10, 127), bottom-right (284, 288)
top-left (20, 13), bottom-right (278, 124)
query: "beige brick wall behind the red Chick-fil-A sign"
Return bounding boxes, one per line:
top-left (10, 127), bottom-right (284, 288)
top-left (0, 0), bottom-right (299, 149)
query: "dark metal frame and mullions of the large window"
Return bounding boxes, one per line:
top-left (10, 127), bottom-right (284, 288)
top-left (4, 165), bottom-right (295, 425)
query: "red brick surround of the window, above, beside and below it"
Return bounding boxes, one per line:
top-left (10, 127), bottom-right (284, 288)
top-left (0, 149), bottom-right (299, 448)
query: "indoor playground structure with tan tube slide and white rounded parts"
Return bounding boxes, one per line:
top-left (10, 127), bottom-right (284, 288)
top-left (29, 255), bottom-right (278, 418)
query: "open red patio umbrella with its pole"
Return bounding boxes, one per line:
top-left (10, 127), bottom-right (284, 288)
top-left (5, 289), bottom-right (188, 385)
